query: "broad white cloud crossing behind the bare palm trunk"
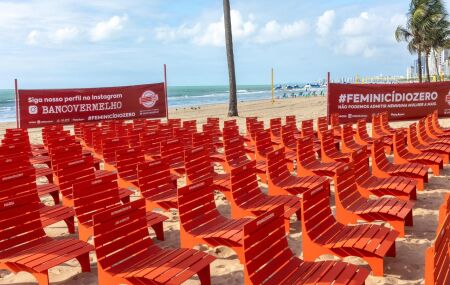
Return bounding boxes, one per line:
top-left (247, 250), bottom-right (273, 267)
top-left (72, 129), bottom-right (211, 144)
top-left (155, 10), bottom-right (309, 47)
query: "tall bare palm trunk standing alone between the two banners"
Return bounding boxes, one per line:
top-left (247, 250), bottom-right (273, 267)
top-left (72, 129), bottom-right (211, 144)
top-left (223, 0), bottom-right (238, 117)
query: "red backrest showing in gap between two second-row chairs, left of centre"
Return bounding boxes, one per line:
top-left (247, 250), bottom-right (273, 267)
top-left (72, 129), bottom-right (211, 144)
top-left (138, 159), bottom-right (175, 200)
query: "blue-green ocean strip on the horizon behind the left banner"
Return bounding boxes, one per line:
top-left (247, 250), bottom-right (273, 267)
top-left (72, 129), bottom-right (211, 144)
top-left (0, 85), bottom-right (323, 122)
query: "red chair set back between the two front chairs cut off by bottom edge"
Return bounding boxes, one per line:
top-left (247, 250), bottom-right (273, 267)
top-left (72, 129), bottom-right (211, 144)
top-left (178, 179), bottom-right (251, 263)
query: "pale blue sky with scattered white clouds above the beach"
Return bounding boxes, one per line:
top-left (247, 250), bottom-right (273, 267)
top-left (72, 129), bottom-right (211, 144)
top-left (0, 0), bottom-right (436, 89)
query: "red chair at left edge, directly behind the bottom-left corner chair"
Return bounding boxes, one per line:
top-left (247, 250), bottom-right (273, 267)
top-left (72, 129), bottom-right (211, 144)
top-left (0, 167), bottom-right (75, 233)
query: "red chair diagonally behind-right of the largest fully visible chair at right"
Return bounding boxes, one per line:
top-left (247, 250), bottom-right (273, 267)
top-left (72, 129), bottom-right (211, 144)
top-left (334, 164), bottom-right (414, 237)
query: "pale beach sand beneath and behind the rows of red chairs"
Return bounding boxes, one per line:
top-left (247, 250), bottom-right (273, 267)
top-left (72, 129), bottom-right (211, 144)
top-left (0, 97), bottom-right (450, 285)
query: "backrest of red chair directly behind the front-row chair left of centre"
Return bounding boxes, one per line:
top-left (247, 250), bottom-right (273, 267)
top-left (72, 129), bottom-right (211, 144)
top-left (73, 173), bottom-right (120, 226)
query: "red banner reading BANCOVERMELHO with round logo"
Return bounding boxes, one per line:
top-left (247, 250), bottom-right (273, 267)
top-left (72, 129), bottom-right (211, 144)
top-left (17, 83), bottom-right (167, 128)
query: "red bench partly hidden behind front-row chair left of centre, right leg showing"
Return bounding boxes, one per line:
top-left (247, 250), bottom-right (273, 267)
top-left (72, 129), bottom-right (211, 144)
top-left (73, 173), bottom-right (167, 241)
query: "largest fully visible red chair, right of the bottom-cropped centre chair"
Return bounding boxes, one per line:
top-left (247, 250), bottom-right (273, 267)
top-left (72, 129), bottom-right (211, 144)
top-left (301, 184), bottom-right (398, 276)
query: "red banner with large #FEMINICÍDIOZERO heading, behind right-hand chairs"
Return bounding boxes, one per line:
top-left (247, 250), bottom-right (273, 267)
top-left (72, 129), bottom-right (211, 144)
top-left (328, 82), bottom-right (450, 123)
